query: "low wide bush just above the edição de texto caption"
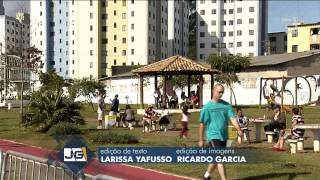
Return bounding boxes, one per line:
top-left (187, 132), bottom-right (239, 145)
top-left (92, 131), bottom-right (139, 144)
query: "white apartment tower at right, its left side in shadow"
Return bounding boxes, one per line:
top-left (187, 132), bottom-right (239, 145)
top-left (196, 0), bottom-right (268, 61)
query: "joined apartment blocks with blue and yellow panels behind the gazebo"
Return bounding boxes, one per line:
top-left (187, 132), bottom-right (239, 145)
top-left (31, 0), bottom-right (188, 78)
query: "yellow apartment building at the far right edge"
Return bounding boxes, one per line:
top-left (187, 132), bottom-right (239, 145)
top-left (288, 22), bottom-right (320, 53)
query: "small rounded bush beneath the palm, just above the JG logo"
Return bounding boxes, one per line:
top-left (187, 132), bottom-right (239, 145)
top-left (49, 122), bottom-right (81, 136)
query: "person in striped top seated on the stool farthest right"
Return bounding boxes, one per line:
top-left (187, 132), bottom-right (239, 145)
top-left (272, 107), bottom-right (304, 151)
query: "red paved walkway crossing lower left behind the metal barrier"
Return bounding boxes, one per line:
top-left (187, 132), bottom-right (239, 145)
top-left (0, 139), bottom-right (189, 180)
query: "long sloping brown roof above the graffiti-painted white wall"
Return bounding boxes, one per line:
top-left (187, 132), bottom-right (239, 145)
top-left (250, 50), bottom-right (320, 66)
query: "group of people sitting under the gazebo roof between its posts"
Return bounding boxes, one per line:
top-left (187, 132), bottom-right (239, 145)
top-left (153, 86), bottom-right (199, 108)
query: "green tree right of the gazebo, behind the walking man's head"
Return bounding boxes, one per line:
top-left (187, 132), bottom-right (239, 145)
top-left (206, 54), bottom-right (250, 104)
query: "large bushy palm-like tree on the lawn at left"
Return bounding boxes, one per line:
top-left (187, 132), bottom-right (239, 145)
top-left (22, 71), bottom-right (84, 132)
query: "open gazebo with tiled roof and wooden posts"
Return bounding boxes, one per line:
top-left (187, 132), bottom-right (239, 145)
top-left (132, 55), bottom-right (219, 108)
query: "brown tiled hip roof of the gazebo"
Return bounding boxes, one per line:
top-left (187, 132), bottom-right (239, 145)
top-left (132, 55), bottom-right (219, 75)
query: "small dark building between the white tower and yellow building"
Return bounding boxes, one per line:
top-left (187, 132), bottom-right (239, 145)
top-left (268, 32), bottom-right (287, 55)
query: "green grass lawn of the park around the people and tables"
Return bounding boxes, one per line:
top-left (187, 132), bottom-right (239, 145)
top-left (0, 106), bottom-right (320, 179)
